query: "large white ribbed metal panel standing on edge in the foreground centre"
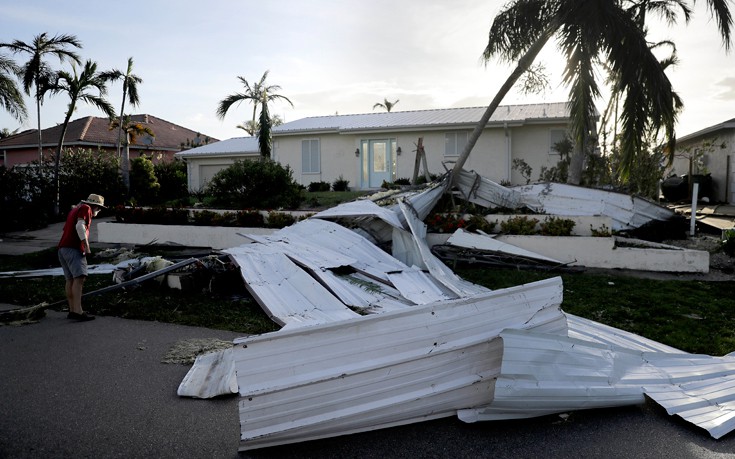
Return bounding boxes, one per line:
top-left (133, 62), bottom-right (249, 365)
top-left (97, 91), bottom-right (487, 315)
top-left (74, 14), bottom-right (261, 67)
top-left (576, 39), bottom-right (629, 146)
top-left (234, 278), bottom-right (566, 450)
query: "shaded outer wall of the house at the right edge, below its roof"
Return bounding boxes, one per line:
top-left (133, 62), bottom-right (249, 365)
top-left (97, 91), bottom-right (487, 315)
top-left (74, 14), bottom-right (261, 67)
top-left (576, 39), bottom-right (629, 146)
top-left (666, 130), bottom-right (735, 204)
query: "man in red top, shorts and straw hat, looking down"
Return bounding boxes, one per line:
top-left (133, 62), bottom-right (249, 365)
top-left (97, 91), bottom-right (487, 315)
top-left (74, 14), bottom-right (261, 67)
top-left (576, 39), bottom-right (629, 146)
top-left (58, 194), bottom-right (105, 322)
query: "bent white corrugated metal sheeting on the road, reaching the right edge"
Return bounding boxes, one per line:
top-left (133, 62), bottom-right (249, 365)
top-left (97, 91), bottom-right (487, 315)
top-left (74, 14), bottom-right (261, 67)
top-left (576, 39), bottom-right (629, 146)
top-left (458, 322), bottom-right (735, 438)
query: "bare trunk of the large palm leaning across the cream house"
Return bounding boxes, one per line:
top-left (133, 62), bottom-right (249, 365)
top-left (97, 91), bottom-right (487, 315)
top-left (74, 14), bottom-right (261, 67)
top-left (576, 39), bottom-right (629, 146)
top-left (447, 21), bottom-right (559, 189)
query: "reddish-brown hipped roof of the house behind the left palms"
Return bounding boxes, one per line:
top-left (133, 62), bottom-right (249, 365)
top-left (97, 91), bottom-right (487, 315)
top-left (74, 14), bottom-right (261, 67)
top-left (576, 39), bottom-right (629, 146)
top-left (0, 115), bottom-right (217, 151)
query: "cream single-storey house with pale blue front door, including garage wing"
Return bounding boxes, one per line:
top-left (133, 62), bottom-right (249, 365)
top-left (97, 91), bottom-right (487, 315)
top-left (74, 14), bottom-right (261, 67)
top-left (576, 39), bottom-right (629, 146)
top-left (177, 102), bottom-right (569, 189)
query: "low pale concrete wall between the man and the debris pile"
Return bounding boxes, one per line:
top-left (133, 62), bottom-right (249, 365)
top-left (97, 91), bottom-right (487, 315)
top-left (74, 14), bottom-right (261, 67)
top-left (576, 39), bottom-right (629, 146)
top-left (97, 222), bottom-right (275, 250)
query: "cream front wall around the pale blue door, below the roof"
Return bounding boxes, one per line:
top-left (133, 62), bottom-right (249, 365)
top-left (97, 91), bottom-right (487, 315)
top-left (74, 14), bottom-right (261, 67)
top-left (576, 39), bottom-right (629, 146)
top-left (273, 123), bottom-right (566, 189)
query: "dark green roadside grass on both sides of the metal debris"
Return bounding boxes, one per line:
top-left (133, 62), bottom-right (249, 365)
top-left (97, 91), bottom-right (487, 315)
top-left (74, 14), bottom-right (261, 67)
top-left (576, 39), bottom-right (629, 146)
top-left (0, 249), bottom-right (735, 355)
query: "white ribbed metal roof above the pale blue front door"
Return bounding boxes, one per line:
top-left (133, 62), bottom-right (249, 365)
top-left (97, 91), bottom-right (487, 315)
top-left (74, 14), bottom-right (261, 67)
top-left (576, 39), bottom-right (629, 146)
top-left (273, 102), bottom-right (569, 136)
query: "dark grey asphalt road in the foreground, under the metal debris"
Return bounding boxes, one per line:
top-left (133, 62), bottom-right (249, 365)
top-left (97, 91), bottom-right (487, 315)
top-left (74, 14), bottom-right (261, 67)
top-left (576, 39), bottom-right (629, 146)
top-left (0, 311), bottom-right (735, 458)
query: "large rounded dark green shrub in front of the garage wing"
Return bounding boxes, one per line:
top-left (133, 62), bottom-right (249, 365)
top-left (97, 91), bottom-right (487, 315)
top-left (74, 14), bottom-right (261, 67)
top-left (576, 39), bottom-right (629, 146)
top-left (207, 159), bottom-right (304, 209)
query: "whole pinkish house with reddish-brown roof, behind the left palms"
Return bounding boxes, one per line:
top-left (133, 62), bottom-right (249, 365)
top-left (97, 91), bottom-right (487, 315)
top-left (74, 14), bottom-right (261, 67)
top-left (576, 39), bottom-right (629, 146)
top-left (0, 115), bottom-right (217, 168)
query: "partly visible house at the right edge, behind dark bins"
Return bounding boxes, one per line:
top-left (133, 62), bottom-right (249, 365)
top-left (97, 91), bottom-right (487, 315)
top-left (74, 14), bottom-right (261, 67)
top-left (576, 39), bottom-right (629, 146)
top-left (670, 119), bottom-right (735, 204)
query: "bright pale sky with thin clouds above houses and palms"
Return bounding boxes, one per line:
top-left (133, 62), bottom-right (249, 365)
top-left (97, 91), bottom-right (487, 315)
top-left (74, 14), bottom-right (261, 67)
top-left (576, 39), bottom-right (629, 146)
top-left (0, 0), bottom-right (735, 144)
